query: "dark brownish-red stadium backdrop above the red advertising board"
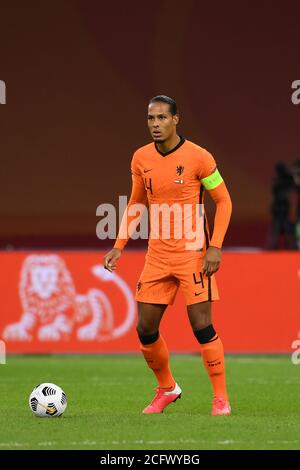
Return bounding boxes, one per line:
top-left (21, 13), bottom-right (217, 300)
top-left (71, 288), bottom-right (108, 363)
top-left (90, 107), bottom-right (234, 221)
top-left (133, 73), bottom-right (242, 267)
top-left (0, 0), bottom-right (300, 248)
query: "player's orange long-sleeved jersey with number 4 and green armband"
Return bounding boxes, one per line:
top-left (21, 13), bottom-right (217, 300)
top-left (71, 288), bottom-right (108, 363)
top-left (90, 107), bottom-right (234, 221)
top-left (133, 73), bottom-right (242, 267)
top-left (115, 138), bottom-right (231, 257)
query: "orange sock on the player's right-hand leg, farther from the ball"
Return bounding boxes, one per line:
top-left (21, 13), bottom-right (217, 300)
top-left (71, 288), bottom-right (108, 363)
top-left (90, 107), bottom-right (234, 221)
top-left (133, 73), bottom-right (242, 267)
top-left (201, 335), bottom-right (228, 400)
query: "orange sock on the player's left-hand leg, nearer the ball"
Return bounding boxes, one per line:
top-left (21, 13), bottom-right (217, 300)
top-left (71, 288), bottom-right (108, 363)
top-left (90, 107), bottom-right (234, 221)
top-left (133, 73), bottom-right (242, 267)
top-left (141, 336), bottom-right (175, 390)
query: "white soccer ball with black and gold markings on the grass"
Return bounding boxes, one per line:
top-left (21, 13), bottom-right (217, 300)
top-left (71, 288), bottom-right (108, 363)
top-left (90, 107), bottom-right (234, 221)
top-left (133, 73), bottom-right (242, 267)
top-left (29, 383), bottom-right (67, 418)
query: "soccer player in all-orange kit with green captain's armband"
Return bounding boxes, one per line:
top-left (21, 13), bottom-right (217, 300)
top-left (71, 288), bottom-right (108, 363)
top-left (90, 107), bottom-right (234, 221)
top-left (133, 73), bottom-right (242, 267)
top-left (104, 95), bottom-right (232, 415)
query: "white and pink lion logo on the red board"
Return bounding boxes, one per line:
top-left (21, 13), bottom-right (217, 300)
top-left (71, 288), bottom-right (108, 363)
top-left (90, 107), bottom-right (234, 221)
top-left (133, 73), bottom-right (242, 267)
top-left (3, 255), bottom-right (135, 341)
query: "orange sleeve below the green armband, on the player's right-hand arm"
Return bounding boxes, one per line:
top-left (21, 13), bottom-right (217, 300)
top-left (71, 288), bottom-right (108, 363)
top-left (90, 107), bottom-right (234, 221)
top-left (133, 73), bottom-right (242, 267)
top-left (209, 182), bottom-right (232, 248)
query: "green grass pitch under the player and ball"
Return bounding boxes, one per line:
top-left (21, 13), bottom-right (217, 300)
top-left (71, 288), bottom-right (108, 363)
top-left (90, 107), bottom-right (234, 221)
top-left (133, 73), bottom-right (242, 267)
top-left (0, 355), bottom-right (300, 450)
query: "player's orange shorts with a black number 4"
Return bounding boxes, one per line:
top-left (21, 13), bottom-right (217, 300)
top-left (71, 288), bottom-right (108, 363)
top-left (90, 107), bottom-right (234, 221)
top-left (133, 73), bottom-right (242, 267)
top-left (135, 253), bottom-right (219, 305)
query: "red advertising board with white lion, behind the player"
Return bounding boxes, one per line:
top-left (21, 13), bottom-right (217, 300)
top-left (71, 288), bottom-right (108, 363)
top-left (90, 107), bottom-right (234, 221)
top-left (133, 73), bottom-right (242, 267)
top-left (0, 251), bottom-right (300, 353)
